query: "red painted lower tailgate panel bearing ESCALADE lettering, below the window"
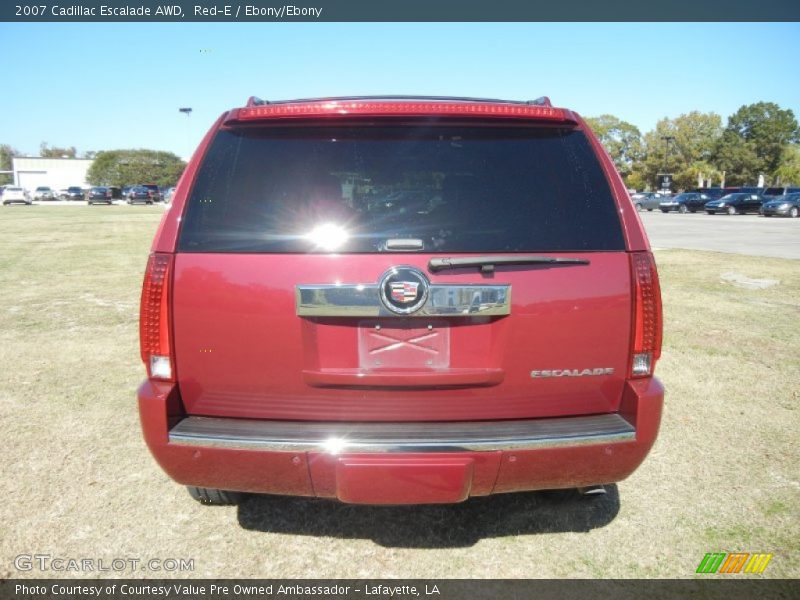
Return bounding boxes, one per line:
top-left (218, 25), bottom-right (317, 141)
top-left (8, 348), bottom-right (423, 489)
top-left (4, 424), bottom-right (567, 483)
top-left (173, 252), bottom-right (631, 421)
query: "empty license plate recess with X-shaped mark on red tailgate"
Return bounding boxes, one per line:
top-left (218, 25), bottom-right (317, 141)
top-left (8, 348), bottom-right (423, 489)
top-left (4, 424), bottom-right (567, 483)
top-left (358, 319), bottom-right (450, 370)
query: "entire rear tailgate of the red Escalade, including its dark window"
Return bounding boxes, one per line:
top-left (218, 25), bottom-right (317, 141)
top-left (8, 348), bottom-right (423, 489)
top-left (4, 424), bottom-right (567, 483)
top-left (173, 118), bottom-right (631, 421)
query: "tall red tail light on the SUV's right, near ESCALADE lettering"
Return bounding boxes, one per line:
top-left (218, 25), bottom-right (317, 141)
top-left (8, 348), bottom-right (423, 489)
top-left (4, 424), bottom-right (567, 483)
top-left (630, 252), bottom-right (662, 377)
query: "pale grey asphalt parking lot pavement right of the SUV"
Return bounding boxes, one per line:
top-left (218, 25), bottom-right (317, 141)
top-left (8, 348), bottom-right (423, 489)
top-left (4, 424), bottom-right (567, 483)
top-left (639, 211), bottom-right (800, 260)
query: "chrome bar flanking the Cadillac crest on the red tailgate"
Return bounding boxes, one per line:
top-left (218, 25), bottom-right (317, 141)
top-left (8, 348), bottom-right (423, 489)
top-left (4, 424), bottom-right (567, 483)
top-left (295, 283), bottom-right (511, 317)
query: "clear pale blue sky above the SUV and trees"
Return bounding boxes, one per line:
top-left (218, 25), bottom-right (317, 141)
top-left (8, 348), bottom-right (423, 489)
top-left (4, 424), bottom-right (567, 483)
top-left (0, 23), bottom-right (800, 157)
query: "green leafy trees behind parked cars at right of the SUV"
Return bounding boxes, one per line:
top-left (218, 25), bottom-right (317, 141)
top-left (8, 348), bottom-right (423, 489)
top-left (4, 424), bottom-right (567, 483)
top-left (586, 102), bottom-right (800, 190)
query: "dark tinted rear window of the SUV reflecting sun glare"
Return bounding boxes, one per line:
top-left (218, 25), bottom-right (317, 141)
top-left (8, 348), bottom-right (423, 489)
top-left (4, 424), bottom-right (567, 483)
top-left (179, 124), bottom-right (624, 253)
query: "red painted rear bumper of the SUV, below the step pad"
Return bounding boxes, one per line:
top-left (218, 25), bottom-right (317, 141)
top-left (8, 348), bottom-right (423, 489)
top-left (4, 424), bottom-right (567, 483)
top-left (139, 379), bottom-right (664, 504)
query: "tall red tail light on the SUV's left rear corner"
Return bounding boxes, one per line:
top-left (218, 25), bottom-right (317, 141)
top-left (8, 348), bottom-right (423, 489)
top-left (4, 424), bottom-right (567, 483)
top-left (139, 253), bottom-right (175, 381)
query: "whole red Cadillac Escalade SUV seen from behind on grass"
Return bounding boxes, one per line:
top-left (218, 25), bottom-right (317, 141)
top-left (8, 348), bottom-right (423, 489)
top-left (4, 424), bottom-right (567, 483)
top-left (138, 96), bottom-right (664, 504)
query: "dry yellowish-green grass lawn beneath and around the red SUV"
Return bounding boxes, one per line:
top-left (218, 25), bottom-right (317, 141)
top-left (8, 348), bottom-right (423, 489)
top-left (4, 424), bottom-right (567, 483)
top-left (0, 206), bottom-right (800, 578)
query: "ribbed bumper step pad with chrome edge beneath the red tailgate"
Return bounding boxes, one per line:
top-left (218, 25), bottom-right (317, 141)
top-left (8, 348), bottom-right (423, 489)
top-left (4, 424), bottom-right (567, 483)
top-left (169, 414), bottom-right (636, 454)
